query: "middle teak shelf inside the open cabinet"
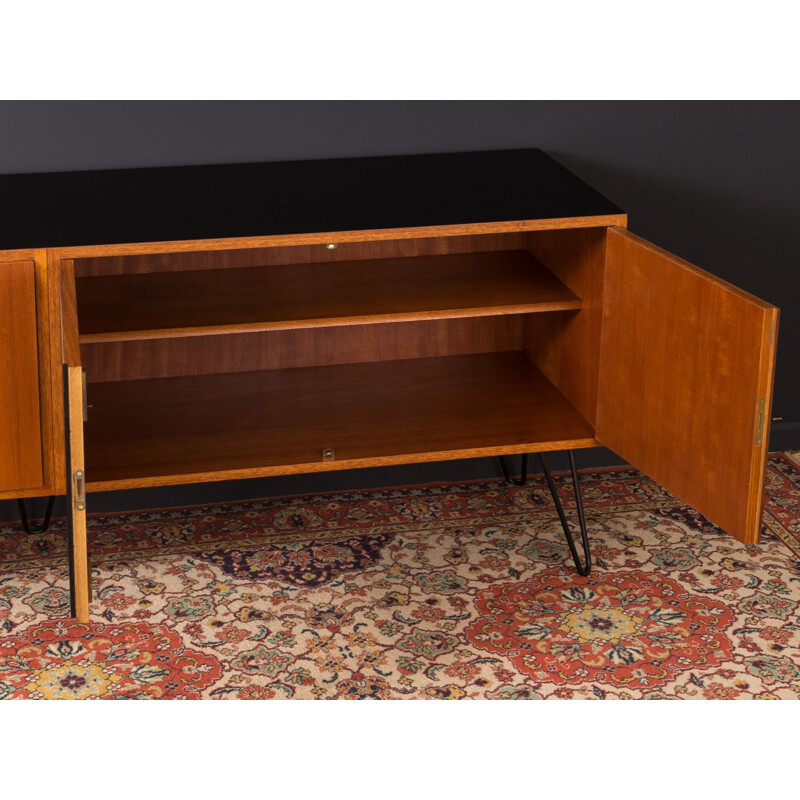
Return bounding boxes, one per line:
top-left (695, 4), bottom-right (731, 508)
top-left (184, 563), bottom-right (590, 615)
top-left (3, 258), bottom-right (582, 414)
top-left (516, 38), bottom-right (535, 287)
top-left (76, 250), bottom-right (581, 344)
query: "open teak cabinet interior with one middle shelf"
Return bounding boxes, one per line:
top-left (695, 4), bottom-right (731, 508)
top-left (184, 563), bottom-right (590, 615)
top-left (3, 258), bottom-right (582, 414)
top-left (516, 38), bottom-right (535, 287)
top-left (65, 228), bottom-right (606, 490)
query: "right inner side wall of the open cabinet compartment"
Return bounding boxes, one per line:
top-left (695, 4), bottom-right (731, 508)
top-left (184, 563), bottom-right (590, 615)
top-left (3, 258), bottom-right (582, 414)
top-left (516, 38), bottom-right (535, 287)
top-left (524, 228), bottom-right (607, 425)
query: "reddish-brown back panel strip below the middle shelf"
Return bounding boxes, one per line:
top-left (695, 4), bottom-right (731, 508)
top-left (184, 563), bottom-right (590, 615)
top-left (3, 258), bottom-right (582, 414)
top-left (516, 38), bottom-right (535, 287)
top-left (81, 315), bottom-right (528, 382)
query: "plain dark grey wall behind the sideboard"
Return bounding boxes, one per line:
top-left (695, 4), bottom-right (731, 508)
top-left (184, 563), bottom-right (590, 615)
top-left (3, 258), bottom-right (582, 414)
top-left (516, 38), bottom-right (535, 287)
top-left (0, 101), bottom-right (800, 503)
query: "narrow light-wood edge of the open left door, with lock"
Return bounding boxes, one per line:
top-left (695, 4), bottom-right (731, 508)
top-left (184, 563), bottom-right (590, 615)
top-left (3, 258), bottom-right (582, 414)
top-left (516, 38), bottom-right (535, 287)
top-left (64, 364), bottom-right (91, 622)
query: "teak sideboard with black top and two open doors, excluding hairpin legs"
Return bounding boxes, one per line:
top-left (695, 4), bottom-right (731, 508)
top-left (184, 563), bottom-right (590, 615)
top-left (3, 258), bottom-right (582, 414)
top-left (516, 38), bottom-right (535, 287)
top-left (0, 149), bottom-right (778, 620)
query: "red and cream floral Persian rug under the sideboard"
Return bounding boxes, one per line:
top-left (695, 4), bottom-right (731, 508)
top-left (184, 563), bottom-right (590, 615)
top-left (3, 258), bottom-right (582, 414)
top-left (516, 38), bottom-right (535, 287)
top-left (0, 455), bottom-right (800, 699)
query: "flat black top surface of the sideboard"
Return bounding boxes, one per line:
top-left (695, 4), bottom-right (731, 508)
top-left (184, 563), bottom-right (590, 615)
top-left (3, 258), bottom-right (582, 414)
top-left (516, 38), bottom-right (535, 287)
top-left (0, 149), bottom-right (622, 249)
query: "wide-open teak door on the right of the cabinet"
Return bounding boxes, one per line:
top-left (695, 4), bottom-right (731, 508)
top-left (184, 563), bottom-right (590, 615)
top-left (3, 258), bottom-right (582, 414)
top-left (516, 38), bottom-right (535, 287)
top-left (596, 228), bottom-right (778, 543)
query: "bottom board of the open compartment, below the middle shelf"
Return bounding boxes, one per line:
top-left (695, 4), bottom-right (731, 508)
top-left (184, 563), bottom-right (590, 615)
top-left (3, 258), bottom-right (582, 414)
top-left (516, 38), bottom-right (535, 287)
top-left (85, 351), bottom-right (597, 491)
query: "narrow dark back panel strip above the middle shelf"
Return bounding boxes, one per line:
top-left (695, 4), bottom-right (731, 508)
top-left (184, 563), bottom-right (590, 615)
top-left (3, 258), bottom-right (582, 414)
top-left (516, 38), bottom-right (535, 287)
top-left (75, 233), bottom-right (525, 278)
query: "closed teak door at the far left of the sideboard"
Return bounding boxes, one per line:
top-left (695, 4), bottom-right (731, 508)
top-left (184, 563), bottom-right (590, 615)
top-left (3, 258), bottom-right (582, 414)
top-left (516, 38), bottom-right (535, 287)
top-left (0, 261), bottom-right (42, 491)
